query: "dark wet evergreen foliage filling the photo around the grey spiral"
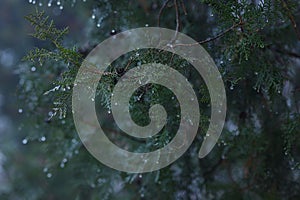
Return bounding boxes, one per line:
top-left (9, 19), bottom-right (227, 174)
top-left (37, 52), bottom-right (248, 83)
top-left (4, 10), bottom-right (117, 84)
top-left (0, 0), bottom-right (300, 200)
